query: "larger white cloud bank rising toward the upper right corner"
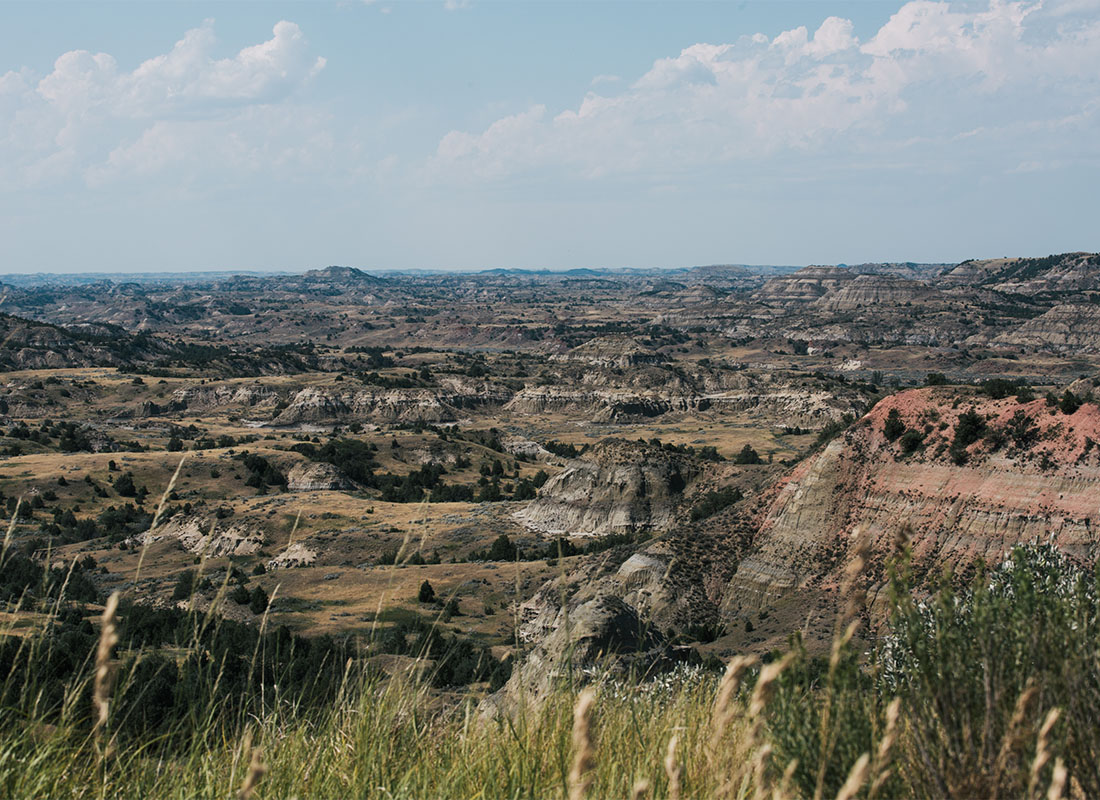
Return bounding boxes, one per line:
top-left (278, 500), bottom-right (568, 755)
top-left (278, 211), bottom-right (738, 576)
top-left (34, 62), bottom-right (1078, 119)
top-left (432, 0), bottom-right (1100, 179)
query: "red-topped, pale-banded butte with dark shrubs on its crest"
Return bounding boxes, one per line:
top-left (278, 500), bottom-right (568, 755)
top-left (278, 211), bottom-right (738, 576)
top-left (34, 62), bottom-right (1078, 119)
top-left (723, 387), bottom-right (1100, 618)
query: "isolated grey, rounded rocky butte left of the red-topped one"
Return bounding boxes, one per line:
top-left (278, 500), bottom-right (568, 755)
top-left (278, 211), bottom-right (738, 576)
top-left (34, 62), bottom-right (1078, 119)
top-left (516, 439), bottom-right (697, 536)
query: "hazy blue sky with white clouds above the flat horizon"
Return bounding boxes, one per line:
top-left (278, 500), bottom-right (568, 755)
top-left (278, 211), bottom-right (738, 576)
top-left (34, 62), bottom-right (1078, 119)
top-left (0, 0), bottom-right (1100, 273)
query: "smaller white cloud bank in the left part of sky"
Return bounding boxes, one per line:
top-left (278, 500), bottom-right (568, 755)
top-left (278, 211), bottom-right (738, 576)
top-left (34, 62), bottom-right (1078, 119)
top-left (0, 21), bottom-right (325, 187)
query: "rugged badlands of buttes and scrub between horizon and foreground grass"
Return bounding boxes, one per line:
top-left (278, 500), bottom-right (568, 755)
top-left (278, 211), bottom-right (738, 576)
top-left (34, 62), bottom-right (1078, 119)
top-left (0, 253), bottom-right (1100, 797)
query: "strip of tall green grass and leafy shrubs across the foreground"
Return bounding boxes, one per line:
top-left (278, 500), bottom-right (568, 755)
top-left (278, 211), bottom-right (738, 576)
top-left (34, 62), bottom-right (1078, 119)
top-left (0, 546), bottom-right (1100, 800)
